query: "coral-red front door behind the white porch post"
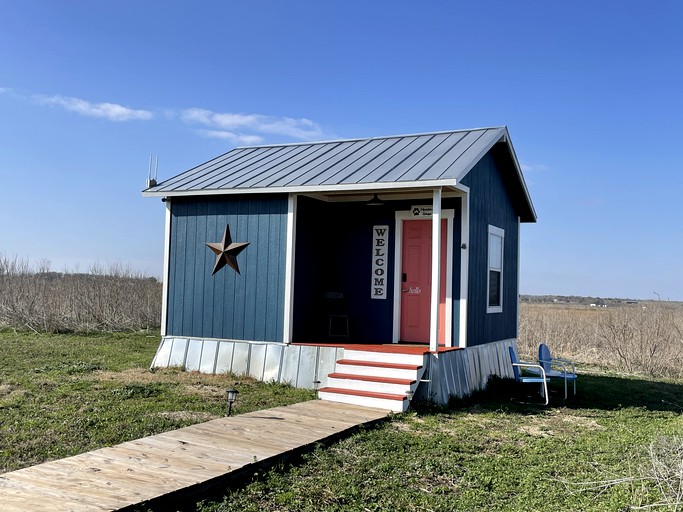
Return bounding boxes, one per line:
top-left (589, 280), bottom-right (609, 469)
top-left (400, 219), bottom-right (448, 345)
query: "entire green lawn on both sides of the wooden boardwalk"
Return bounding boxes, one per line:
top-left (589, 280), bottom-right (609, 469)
top-left (0, 332), bottom-right (683, 512)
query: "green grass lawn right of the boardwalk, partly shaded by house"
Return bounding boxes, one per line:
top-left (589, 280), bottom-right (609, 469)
top-left (194, 375), bottom-right (683, 512)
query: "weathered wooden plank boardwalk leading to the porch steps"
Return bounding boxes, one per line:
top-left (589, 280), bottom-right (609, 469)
top-left (0, 400), bottom-right (387, 512)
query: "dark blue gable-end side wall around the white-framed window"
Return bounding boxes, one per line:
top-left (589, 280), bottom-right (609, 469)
top-left (462, 150), bottom-right (519, 345)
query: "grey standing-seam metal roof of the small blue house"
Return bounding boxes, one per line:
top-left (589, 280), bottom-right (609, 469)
top-left (143, 127), bottom-right (535, 219)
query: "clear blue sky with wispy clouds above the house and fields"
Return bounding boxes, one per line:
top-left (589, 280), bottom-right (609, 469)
top-left (0, 0), bottom-right (683, 300)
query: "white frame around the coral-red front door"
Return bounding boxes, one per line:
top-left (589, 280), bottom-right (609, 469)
top-left (392, 210), bottom-right (455, 347)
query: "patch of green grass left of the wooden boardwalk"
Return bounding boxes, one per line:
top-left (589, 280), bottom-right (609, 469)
top-left (0, 330), bottom-right (313, 473)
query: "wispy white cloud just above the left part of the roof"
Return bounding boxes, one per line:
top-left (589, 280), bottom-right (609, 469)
top-left (180, 108), bottom-right (324, 143)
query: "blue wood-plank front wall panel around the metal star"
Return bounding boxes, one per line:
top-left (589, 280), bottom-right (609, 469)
top-left (167, 195), bottom-right (287, 341)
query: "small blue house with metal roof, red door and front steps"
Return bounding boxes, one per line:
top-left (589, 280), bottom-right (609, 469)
top-left (143, 127), bottom-right (536, 410)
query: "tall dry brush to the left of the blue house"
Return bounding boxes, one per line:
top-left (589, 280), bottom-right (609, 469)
top-left (0, 255), bottom-right (161, 333)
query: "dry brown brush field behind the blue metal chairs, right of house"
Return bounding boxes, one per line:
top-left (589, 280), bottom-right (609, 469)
top-left (519, 302), bottom-right (683, 377)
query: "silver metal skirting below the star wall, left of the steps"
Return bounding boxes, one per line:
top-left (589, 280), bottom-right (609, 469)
top-left (151, 337), bottom-right (344, 389)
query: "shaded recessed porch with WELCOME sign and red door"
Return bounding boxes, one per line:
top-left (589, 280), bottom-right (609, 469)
top-left (284, 190), bottom-right (467, 350)
